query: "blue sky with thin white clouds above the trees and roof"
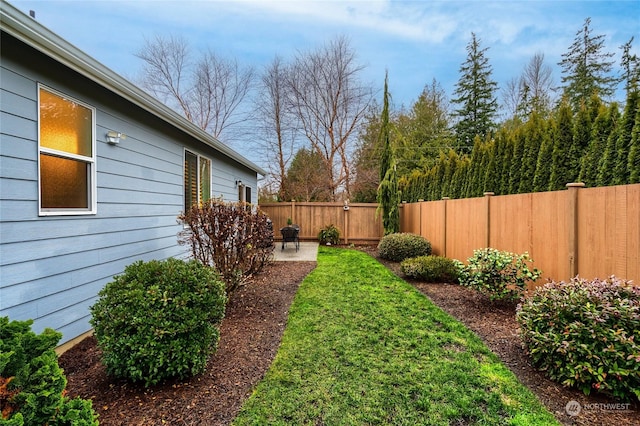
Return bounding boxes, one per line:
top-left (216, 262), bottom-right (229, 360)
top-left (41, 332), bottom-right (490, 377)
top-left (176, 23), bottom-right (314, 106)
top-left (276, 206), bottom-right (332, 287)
top-left (9, 0), bottom-right (640, 162)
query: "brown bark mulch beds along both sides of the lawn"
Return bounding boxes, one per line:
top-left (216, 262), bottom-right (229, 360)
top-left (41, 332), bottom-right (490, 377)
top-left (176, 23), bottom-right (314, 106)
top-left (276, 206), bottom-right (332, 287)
top-left (60, 247), bottom-right (640, 426)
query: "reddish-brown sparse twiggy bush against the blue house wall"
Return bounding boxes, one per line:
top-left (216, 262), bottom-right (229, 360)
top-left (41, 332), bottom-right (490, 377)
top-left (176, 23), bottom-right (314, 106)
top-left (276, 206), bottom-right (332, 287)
top-left (178, 198), bottom-right (274, 293)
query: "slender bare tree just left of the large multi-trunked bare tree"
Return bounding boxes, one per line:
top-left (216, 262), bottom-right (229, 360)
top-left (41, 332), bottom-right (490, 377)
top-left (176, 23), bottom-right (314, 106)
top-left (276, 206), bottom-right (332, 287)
top-left (256, 56), bottom-right (298, 200)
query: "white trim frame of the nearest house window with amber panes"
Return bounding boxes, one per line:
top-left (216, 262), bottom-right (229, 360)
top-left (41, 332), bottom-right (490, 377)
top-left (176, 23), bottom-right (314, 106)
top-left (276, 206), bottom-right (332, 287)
top-left (37, 83), bottom-right (98, 216)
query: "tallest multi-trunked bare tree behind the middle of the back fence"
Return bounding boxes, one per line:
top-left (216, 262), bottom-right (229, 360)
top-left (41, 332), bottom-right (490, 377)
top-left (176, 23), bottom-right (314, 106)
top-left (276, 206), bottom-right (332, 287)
top-left (289, 37), bottom-right (373, 200)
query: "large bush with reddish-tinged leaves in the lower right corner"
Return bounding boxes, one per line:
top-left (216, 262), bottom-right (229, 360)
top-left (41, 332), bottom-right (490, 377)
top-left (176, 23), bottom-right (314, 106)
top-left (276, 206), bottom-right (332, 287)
top-left (516, 277), bottom-right (640, 399)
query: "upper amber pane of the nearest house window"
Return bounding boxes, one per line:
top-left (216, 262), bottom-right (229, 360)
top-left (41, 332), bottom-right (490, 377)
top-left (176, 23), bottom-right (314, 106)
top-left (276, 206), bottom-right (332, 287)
top-left (40, 89), bottom-right (93, 157)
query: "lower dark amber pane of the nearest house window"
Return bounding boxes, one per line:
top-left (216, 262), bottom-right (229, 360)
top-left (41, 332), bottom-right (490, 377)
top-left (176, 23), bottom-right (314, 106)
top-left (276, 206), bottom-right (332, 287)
top-left (40, 154), bottom-right (91, 209)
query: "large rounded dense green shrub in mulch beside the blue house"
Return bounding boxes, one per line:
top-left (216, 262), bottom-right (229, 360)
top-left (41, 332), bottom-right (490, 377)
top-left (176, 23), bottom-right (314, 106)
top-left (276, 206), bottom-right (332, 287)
top-left (91, 259), bottom-right (227, 386)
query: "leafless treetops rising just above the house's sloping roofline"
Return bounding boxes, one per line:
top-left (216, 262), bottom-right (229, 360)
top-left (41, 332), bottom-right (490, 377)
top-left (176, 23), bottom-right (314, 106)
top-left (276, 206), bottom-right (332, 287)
top-left (136, 35), bottom-right (254, 139)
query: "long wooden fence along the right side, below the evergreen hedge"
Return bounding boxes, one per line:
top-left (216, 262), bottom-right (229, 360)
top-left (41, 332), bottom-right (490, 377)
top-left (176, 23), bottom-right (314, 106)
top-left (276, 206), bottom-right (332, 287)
top-left (400, 184), bottom-right (640, 285)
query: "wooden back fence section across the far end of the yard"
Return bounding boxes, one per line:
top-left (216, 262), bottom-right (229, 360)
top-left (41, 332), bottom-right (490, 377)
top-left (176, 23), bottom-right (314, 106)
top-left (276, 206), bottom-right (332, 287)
top-left (260, 202), bottom-right (384, 244)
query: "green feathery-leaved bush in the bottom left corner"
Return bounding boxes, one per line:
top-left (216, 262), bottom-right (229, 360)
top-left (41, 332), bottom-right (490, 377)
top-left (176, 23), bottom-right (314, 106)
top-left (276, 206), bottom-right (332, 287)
top-left (0, 317), bottom-right (98, 426)
